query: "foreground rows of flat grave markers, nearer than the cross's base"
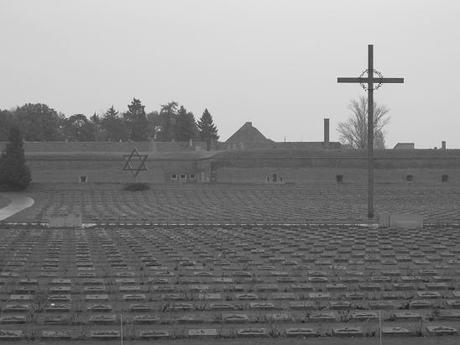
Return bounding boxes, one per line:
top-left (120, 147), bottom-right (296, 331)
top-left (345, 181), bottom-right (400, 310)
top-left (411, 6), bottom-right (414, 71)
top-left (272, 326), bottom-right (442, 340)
top-left (0, 224), bottom-right (460, 345)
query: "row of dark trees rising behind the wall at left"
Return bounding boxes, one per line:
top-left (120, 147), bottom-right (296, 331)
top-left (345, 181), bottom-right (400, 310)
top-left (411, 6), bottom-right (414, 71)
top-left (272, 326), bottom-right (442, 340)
top-left (0, 98), bottom-right (219, 149)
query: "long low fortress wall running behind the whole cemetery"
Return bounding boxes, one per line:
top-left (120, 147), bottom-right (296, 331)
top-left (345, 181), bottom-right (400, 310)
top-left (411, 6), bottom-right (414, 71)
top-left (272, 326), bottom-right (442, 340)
top-left (6, 143), bottom-right (460, 185)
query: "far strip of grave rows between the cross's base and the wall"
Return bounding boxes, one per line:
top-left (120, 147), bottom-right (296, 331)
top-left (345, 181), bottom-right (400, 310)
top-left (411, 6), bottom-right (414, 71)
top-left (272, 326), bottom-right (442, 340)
top-left (8, 184), bottom-right (460, 223)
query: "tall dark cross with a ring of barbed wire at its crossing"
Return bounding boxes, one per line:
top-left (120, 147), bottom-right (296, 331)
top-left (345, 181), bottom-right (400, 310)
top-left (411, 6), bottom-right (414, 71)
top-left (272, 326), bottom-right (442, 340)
top-left (337, 44), bottom-right (404, 218)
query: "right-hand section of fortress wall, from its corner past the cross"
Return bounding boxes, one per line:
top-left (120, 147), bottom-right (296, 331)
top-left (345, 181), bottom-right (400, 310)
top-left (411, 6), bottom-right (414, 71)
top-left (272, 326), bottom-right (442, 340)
top-left (213, 150), bottom-right (460, 185)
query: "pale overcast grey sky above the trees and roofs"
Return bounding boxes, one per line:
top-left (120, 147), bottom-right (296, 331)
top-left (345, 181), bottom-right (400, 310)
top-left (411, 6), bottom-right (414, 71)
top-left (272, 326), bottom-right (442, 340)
top-left (0, 0), bottom-right (460, 148)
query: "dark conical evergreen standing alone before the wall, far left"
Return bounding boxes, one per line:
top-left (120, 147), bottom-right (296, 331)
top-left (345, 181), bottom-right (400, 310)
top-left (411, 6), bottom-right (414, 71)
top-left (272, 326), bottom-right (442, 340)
top-left (0, 127), bottom-right (32, 190)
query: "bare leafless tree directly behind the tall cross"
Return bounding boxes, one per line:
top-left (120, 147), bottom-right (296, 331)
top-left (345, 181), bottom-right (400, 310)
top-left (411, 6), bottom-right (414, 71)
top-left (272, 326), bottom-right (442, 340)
top-left (337, 96), bottom-right (390, 149)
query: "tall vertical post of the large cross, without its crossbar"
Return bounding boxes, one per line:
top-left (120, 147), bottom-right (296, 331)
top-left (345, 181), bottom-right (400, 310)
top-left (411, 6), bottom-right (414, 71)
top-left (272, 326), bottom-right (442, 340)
top-left (367, 44), bottom-right (374, 218)
